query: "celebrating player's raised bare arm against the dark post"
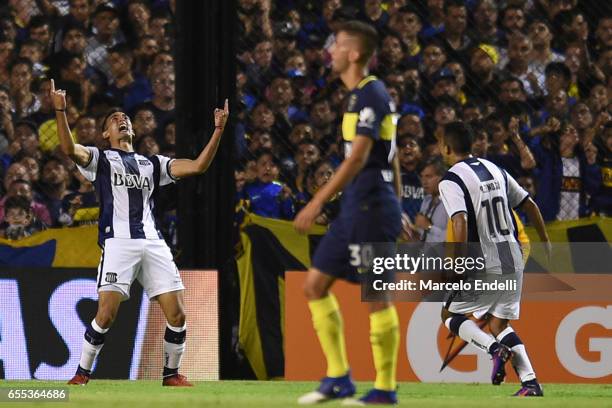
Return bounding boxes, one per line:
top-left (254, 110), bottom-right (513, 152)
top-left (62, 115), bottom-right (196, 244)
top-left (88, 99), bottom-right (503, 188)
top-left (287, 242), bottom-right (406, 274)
top-left (170, 99), bottom-right (229, 178)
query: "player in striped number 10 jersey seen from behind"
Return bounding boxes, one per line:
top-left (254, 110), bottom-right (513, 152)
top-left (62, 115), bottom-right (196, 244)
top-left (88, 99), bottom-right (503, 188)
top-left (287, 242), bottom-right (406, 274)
top-left (439, 122), bottom-right (551, 396)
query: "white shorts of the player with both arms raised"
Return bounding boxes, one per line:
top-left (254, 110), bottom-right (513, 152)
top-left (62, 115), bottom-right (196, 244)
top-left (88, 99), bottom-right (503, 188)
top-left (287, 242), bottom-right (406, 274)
top-left (98, 238), bottom-right (185, 300)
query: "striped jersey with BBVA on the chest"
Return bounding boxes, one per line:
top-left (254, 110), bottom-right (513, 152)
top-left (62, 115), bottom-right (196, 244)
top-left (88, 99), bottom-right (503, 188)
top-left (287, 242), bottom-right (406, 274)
top-left (77, 147), bottom-right (176, 247)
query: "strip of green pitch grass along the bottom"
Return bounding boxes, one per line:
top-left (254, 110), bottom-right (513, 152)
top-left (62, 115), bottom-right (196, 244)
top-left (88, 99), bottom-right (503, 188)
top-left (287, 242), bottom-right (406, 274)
top-left (0, 380), bottom-right (612, 408)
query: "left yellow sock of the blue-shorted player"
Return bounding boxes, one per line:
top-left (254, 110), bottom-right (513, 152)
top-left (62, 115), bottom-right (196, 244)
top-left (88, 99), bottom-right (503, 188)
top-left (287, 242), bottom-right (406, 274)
top-left (308, 293), bottom-right (349, 377)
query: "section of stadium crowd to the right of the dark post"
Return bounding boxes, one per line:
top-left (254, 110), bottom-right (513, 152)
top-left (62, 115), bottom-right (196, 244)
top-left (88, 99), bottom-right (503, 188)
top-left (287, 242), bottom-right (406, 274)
top-left (235, 0), bottom-right (612, 230)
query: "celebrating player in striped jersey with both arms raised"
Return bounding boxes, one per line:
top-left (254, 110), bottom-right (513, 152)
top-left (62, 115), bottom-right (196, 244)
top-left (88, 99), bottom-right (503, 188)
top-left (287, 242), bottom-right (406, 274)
top-left (51, 80), bottom-right (229, 386)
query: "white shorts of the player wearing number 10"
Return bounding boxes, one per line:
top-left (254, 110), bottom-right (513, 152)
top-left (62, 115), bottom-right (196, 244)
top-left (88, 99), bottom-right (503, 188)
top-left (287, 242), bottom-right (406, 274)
top-left (448, 273), bottom-right (523, 320)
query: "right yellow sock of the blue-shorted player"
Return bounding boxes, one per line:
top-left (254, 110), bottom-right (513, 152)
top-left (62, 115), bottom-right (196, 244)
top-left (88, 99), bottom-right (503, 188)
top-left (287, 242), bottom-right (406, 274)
top-left (370, 306), bottom-right (399, 391)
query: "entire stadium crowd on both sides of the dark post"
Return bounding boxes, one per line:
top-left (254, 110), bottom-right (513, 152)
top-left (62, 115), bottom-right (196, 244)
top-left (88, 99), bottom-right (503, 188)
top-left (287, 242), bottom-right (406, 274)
top-left (0, 0), bottom-right (612, 242)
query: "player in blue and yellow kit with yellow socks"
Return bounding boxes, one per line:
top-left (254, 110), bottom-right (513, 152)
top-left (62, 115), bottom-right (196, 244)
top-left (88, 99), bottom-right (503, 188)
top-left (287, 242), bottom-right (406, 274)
top-left (294, 21), bottom-right (402, 405)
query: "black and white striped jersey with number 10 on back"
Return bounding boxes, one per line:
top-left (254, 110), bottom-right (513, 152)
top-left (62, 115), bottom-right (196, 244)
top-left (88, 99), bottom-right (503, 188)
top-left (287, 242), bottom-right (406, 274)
top-left (439, 157), bottom-right (529, 274)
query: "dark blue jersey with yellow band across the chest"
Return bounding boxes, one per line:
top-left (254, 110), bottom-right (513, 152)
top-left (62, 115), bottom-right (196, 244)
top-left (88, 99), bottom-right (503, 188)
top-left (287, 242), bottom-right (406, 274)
top-left (342, 76), bottom-right (397, 205)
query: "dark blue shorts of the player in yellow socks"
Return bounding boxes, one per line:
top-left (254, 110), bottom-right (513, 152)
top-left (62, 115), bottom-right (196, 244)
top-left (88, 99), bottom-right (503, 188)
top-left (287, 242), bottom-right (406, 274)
top-left (312, 197), bottom-right (402, 283)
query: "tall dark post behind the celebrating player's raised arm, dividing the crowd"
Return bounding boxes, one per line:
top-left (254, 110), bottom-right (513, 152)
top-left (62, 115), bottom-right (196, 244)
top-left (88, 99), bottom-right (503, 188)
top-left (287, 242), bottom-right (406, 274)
top-left (175, 0), bottom-right (237, 269)
